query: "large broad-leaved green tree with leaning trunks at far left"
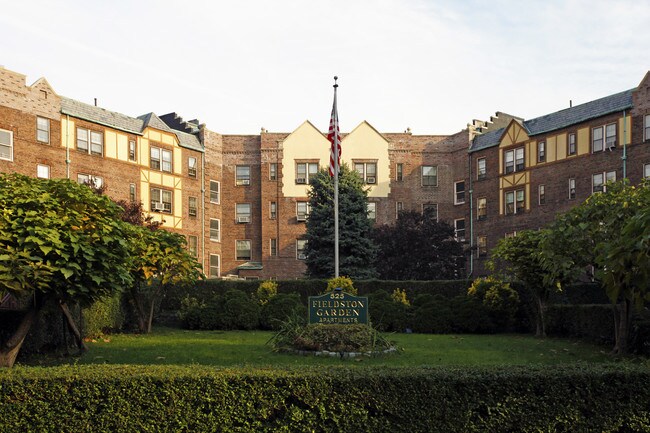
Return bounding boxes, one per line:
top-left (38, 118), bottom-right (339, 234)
top-left (0, 174), bottom-right (131, 367)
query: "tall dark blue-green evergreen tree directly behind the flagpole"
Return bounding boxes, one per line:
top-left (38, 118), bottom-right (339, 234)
top-left (305, 164), bottom-right (376, 279)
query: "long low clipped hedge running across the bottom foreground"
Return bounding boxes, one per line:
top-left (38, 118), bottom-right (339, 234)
top-left (0, 364), bottom-right (650, 433)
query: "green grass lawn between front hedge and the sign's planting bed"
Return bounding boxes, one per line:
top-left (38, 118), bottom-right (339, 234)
top-left (30, 328), bottom-right (614, 368)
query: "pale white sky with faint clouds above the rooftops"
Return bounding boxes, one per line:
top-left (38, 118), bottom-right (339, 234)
top-left (0, 0), bottom-right (650, 134)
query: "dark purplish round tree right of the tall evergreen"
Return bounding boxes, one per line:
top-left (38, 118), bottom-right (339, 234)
top-left (373, 209), bottom-right (465, 280)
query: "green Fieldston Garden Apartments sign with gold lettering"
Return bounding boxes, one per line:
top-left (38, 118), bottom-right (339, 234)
top-left (309, 289), bottom-right (368, 325)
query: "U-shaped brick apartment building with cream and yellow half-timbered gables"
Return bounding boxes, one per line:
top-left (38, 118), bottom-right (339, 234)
top-left (0, 68), bottom-right (650, 278)
